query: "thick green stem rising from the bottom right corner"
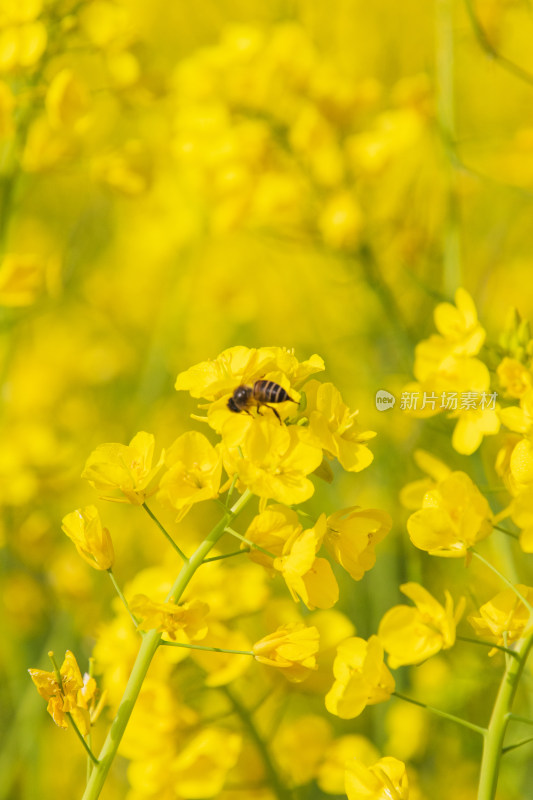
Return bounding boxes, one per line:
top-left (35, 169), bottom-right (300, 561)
top-left (477, 634), bottom-right (533, 800)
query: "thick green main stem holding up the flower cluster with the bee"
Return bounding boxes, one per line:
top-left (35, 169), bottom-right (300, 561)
top-left (82, 490), bottom-right (252, 800)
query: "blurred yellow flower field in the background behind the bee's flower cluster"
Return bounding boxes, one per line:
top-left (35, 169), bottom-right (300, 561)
top-left (0, 0), bottom-right (533, 800)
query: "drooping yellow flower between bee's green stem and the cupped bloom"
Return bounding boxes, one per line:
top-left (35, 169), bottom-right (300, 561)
top-left (274, 514), bottom-right (339, 609)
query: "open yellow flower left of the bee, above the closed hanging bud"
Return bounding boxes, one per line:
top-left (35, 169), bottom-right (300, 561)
top-left (81, 431), bottom-right (163, 506)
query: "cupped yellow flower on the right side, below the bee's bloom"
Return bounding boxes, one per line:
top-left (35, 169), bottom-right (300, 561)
top-left (324, 506), bottom-right (392, 581)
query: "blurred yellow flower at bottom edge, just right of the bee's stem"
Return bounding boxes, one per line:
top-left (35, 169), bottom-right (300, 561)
top-left (172, 727), bottom-right (242, 800)
